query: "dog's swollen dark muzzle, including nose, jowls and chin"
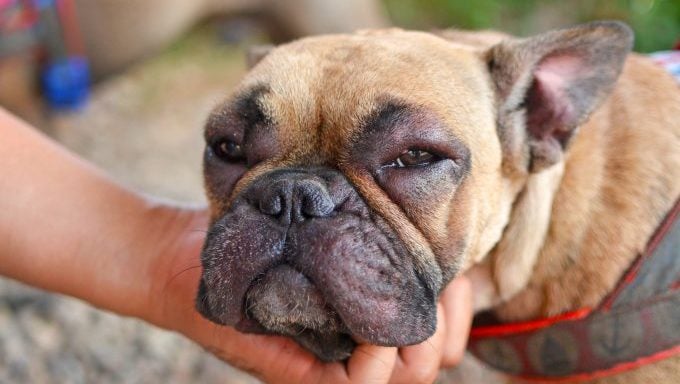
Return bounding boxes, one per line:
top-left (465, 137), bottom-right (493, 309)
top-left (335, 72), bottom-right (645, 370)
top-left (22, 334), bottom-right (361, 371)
top-left (197, 168), bottom-right (437, 360)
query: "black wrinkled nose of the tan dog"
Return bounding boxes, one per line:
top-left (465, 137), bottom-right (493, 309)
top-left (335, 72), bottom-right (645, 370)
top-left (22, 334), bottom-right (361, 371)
top-left (254, 175), bottom-right (335, 225)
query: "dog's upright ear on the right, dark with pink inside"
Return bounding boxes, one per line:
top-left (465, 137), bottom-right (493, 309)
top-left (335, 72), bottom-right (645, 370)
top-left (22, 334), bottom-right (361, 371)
top-left (486, 21), bottom-right (633, 172)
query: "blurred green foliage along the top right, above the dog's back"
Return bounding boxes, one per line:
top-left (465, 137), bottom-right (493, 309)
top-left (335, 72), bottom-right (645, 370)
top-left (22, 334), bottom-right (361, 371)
top-left (384, 0), bottom-right (680, 52)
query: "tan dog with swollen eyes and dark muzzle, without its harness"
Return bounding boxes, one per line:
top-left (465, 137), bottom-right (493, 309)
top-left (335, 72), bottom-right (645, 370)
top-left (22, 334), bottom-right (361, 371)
top-left (196, 21), bottom-right (680, 382)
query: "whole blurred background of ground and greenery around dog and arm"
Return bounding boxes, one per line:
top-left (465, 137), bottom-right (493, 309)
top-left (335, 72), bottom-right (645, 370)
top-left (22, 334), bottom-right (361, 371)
top-left (0, 0), bottom-right (680, 383)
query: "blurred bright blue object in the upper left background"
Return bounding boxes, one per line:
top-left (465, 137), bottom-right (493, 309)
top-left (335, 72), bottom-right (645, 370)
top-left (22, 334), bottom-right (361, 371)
top-left (42, 56), bottom-right (90, 110)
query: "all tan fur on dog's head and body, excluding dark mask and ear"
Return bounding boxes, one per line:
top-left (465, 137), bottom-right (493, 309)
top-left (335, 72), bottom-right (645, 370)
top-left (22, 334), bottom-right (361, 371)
top-left (211, 29), bottom-right (680, 382)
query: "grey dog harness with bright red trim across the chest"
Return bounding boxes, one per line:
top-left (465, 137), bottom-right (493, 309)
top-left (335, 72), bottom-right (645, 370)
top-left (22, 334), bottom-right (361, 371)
top-left (468, 199), bottom-right (680, 382)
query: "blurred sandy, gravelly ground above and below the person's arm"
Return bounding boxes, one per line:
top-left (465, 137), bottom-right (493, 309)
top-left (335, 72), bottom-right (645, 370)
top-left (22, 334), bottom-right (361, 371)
top-left (0, 25), bottom-right (495, 384)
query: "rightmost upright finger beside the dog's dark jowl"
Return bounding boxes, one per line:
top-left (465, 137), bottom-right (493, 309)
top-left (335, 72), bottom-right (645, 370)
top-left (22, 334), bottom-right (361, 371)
top-left (439, 276), bottom-right (472, 368)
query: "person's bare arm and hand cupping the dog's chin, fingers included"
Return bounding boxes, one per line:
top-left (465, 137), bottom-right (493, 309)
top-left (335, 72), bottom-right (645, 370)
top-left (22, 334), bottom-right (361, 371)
top-left (0, 108), bottom-right (472, 383)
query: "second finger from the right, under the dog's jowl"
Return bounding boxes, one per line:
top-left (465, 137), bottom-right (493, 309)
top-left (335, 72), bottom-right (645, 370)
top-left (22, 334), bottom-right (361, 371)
top-left (390, 304), bottom-right (446, 384)
